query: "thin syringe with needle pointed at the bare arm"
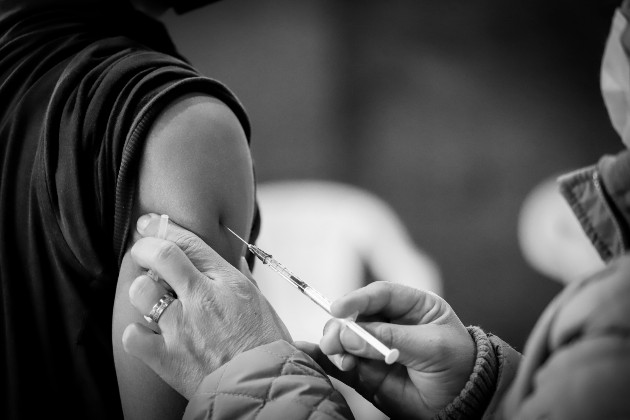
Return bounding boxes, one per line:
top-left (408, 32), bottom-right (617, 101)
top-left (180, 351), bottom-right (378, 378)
top-left (225, 226), bottom-right (400, 365)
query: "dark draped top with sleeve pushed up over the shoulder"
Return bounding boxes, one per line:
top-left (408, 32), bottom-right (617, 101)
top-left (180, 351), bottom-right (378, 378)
top-left (0, 1), bottom-right (254, 419)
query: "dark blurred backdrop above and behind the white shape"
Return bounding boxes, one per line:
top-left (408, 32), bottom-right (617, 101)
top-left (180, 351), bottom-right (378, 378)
top-left (165, 0), bottom-right (622, 362)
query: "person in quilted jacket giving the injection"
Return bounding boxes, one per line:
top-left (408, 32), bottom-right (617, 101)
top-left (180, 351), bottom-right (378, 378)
top-left (124, 0), bottom-right (630, 419)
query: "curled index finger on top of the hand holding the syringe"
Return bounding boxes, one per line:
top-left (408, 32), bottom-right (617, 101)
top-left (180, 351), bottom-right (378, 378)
top-left (331, 281), bottom-right (435, 323)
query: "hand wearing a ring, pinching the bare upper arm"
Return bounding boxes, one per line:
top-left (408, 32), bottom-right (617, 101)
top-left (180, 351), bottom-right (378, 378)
top-left (123, 215), bottom-right (291, 399)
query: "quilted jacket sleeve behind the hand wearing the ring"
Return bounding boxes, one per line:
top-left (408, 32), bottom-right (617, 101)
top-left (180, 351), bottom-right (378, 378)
top-left (184, 341), bottom-right (353, 420)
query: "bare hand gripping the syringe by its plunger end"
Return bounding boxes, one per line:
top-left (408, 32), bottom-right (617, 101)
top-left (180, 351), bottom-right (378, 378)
top-left (295, 282), bottom-right (476, 419)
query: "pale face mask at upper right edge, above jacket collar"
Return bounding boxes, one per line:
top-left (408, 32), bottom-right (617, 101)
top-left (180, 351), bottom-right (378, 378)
top-left (601, 10), bottom-right (630, 148)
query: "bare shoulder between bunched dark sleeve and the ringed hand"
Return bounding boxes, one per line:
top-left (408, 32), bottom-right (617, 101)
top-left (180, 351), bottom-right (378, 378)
top-left (137, 93), bottom-right (255, 263)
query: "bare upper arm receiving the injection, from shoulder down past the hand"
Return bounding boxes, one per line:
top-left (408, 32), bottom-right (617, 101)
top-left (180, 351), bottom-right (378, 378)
top-left (112, 95), bottom-right (254, 419)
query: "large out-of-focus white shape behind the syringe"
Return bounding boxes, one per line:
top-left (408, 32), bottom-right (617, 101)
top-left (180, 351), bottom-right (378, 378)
top-left (253, 179), bottom-right (442, 420)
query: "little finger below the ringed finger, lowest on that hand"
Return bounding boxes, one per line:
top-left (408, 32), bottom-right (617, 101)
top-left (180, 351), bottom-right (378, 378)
top-left (122, 323), bottom-right (165, 374)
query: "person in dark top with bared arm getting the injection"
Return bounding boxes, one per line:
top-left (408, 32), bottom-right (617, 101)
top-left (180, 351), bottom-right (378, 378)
top-left (0, 0), bottom-right (257, 419)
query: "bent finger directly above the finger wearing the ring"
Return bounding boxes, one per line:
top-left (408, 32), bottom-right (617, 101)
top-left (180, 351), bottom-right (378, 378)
top-left (131, 237), bottom-right (211, 299)
